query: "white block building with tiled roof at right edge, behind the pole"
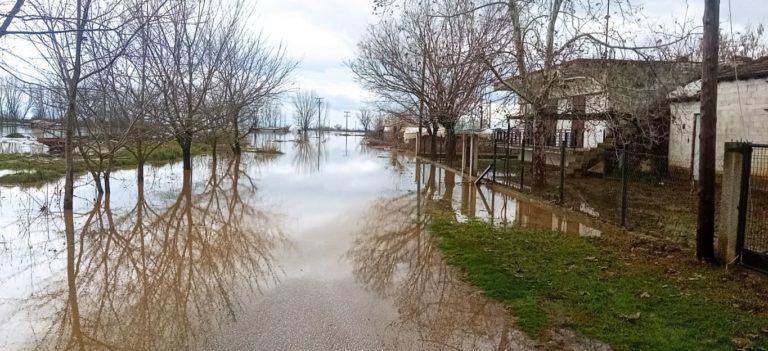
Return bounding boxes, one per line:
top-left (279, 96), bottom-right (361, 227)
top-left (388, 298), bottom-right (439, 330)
top-left (669, 57), bottom-right (768, 179)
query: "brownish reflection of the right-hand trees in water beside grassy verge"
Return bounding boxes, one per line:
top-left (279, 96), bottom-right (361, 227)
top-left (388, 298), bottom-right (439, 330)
top-left (349, 169), bottom-right (522, 350)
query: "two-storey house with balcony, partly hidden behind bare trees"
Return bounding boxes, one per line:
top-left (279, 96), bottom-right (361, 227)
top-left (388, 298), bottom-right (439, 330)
top-left (496, 59), bottom-right (700, 151)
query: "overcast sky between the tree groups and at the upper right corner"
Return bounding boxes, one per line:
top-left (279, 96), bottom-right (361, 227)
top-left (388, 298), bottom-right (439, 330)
top-left (251, 0), bottom-right (768, 126)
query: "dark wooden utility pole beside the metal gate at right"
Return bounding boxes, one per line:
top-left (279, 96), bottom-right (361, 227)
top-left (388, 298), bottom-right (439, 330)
top-left (696, 0), bottom-right (720, 262)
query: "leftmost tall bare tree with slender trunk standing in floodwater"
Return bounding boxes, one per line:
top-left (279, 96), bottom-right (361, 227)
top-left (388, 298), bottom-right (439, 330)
top-left (25, 0), bottom-right (165, 210)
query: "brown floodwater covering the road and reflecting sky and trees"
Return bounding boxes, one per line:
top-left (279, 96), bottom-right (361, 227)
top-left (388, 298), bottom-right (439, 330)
top-left (0, 135), bottom-right (600, 350)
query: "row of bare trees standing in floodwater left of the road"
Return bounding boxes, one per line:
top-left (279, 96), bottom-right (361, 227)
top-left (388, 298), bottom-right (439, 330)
top-left (0, 0), bottom-right (297, 210)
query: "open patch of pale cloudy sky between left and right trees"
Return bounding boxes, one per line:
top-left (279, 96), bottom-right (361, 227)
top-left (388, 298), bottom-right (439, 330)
top-left (251, 0), bottom-right (376, 127)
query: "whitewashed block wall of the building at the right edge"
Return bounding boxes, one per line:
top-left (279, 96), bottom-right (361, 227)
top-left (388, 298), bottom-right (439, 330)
top-left (669, 79), bottom-right (768, 172)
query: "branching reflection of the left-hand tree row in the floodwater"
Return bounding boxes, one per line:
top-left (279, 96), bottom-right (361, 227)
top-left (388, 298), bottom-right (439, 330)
top-left (35, 158), bottom-right (281, 350)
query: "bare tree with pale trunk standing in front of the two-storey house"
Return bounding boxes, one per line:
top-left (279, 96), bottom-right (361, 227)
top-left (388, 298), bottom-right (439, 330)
top-left (412, 0), bottom-right (693, 186)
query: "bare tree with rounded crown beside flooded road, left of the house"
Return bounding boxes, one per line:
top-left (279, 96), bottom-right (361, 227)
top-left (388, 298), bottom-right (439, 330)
top-left (348, 0), bottom-right (508, 162)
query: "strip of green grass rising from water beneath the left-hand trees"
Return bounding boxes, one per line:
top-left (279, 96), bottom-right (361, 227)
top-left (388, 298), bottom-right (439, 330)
top-left (0, 142), bottom-right (211, 186)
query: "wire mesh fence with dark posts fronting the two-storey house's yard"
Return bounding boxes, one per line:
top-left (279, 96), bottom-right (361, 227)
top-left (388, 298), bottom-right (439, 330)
top-left (480, 139), bottom-right (704, 243)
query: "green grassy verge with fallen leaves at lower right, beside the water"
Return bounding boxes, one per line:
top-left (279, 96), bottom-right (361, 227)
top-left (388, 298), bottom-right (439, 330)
top-left (432, 219), bottom-right (768, 350)
